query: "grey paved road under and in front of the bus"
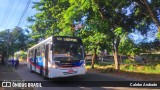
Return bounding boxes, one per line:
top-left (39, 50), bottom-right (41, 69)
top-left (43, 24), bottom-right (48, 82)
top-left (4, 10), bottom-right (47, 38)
top-left (16, 62), bottom-right (134, 81)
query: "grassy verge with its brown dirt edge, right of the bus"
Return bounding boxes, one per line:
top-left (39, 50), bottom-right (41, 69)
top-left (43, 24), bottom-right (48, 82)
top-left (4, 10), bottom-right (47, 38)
top-left (86, 63), bottom-right (160, 81)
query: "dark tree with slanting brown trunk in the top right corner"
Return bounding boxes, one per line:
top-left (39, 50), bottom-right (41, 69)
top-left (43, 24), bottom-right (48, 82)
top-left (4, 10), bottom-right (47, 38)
top-left (130, 0), bottom-right (160, 39)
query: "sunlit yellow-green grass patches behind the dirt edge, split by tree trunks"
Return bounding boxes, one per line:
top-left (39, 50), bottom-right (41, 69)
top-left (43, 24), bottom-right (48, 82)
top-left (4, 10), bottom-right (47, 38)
top-left (86, 61), bottom-right (160, 74)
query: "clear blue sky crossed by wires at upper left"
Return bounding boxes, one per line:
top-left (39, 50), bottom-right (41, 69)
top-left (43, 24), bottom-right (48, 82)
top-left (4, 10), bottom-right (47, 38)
top-left (0, 0), bottom-right (39, 31)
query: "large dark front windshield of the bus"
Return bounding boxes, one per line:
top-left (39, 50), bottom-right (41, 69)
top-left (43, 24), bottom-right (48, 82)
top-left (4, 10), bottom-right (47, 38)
top-left (53, 44), bottom-right (84, 61)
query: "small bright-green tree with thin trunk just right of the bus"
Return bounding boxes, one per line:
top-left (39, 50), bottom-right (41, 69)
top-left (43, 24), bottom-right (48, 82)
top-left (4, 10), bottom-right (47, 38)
top-left (77, 26), bottom-right (106, 68)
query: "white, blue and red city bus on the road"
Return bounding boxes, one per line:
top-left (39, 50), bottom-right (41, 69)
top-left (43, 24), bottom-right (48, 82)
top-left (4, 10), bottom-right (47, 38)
top-left (27, 36), bottom-right (86, 79)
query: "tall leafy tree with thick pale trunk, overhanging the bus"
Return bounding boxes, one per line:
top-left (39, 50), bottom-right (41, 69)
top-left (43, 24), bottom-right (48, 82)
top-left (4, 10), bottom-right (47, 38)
top-left (60, 0), bottom-right (136, 69)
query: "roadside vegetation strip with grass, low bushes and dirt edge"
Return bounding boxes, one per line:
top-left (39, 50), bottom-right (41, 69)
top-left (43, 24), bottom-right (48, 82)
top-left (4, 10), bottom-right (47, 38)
top-left (86, 54), bottom-right (160, 81)
